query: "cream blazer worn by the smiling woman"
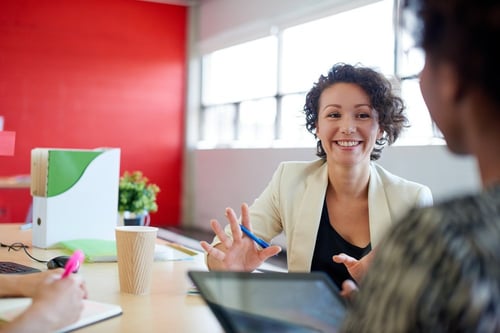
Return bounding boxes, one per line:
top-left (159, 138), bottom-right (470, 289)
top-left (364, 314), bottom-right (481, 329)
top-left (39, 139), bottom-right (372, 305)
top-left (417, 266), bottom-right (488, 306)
top-left (220, 159), bottom-right (432, 271)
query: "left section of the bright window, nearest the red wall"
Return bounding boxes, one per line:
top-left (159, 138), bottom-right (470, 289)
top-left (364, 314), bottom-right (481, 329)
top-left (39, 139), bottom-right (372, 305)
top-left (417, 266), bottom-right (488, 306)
top-left (200, 36), bottom-right (278, 148)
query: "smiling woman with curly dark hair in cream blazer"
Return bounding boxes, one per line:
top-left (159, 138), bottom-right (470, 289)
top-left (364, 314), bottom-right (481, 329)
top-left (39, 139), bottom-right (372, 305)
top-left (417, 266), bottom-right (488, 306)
top-left (201, 64), bottom-right (432, 287)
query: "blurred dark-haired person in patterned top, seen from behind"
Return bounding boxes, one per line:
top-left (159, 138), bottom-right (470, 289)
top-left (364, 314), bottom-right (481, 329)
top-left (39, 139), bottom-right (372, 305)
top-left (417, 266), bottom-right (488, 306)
top-left (344, 0), bottom-right (500, 333)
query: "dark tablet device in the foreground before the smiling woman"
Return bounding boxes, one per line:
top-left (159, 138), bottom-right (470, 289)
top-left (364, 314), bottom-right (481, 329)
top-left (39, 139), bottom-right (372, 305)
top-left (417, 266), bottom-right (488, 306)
top-left (188, 271), bottom-right (346, 333)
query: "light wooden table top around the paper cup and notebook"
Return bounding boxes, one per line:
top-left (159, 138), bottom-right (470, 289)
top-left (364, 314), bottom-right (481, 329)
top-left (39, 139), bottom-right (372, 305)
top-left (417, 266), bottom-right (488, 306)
top-left (0, 223), bottom-right (223, 333)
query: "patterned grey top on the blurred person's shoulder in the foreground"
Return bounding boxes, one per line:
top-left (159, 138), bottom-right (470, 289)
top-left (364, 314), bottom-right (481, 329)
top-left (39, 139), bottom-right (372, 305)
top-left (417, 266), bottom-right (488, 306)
top-left (350, 186), bottom-right (500, 332)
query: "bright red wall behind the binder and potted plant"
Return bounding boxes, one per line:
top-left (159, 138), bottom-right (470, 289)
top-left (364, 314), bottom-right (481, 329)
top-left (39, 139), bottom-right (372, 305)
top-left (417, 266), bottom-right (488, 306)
top-left (0, 0), bottom-right (188, 226)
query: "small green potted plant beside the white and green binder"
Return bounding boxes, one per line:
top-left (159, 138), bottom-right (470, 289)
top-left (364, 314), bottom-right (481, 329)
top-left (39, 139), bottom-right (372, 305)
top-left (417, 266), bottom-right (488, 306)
top-left (118, 171), bottom-right (160, 225)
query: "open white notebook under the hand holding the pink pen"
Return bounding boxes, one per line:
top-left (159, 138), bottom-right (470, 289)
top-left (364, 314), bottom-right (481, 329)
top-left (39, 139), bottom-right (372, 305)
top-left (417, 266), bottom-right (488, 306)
top-left (0, 297), bottom-right (122, 332)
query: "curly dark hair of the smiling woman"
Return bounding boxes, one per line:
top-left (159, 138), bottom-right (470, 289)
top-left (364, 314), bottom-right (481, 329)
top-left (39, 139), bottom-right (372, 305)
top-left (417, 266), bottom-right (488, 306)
top-left (304, 63), bottom-right (408, 161)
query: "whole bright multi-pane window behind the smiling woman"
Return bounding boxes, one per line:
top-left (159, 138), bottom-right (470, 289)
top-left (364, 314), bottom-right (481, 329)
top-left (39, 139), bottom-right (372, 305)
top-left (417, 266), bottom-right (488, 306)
top-left (198, 0), bottom-right (442, 148)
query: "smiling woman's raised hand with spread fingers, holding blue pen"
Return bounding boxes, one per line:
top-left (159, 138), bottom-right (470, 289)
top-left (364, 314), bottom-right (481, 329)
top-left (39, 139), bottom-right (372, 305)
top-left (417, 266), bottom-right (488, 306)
top-left (200, 203), bottom-right (281, 271)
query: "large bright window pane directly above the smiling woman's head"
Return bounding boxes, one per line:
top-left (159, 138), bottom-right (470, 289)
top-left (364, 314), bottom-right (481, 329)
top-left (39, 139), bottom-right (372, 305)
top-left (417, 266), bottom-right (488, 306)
top-left (280, 1), bottom-right (394, 93)
